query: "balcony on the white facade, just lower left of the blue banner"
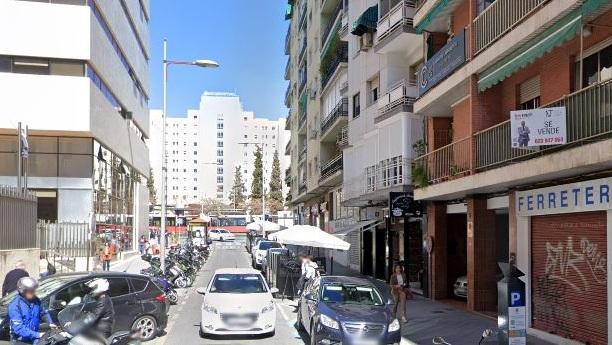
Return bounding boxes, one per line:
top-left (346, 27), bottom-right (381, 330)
top-left (374, 80), bottom-right (417, 123)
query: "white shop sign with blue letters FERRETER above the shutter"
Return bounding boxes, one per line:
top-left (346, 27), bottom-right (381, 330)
top-left (516, 177), bottom-right (612, 217)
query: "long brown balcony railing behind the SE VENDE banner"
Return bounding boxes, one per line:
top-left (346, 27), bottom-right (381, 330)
top-left (413, 80), bottom-right (612, 187)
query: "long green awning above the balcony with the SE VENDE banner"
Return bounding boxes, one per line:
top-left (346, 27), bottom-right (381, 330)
top-left (478, 0), bottom-right (604, 91)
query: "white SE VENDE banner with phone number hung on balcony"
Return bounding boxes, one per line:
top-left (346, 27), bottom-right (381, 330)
top-left (510, 107), bottom-right (567, 147)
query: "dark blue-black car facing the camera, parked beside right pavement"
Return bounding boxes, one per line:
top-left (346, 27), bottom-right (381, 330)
top-left (297, 276), bottom-right (401, 345)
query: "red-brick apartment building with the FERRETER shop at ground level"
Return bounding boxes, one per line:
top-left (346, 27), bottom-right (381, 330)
top-left (412, 0), bottom-right (612, 344)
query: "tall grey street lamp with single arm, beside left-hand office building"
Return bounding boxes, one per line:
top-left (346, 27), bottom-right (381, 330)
top-left (159, 38), bottom-right (219, 272)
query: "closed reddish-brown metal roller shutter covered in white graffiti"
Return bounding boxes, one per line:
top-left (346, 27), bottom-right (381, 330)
top-left (531, 212), bottom-right (607, 345)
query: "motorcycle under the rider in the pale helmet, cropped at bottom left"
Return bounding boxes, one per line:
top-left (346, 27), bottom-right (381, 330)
top-left (37, 300), bottom-right (137, 345)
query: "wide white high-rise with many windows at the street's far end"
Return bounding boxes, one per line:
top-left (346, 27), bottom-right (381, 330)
top-left (149, 92), bottom-right (289, 205)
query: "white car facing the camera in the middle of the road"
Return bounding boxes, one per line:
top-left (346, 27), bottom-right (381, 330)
top-left (197, 268), bottom-right (278, 337)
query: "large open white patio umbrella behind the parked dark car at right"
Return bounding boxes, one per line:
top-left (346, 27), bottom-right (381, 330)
top-left (268, 225), bottom-right (351, 250)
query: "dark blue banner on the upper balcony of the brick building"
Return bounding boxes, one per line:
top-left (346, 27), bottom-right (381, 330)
top-left (419, 30), bottom-right (465, 96)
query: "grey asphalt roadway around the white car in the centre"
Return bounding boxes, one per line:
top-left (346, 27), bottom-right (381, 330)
top-left (151, 242), bottom-right (308, 345)
